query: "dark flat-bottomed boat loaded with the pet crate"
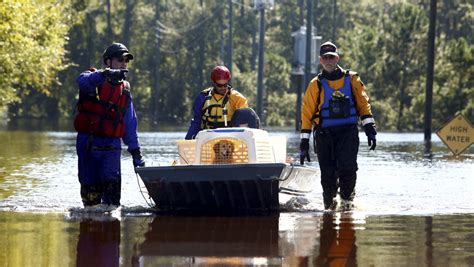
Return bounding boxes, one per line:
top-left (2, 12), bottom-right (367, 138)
top-left (135, 127), bottom-right (319, 214)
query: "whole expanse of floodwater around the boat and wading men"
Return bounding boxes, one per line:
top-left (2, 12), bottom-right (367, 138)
top-left (0, 130), bottom-right (474, 266)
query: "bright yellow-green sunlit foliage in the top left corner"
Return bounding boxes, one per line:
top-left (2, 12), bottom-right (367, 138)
top-left (0, 0), bottom-right (69, 112)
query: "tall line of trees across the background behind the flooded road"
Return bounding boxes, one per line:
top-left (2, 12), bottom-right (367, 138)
top-left (0, 0), bottom-right (474, 131)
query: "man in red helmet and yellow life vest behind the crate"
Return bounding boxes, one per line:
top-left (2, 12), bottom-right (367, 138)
top-left (185, 66), bottom-right (248, 140)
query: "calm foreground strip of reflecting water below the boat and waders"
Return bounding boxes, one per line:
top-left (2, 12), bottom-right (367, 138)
top-left (0, 212), bottom-right (474, 266)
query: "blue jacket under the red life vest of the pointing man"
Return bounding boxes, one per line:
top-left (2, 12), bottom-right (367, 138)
top-left (76, 70), bottom-right (140, 151)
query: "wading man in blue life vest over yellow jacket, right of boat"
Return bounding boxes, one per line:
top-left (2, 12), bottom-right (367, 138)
top-left (300, 42), bottom-right (377, 209)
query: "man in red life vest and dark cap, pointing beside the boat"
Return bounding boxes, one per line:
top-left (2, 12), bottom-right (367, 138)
top-left (74, 43), bottom-right (145, 208)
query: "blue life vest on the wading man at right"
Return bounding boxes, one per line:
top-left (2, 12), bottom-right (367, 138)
top-left (319, 73), bottom-right (358, 128)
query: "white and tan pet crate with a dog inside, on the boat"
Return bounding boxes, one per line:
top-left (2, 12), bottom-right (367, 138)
top-left (177, 128), bottom-right (286, 165)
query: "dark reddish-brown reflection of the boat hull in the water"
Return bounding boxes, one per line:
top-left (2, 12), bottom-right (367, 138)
top-left (131, 215), bottom-right (281, 266)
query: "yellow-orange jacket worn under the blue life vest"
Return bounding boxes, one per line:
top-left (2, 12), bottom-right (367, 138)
top-left (301, 69), bottom-right (374, 135)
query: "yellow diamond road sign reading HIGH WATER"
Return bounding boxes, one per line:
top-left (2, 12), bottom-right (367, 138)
top-left (436, 114), bottom-right (474, 155)
